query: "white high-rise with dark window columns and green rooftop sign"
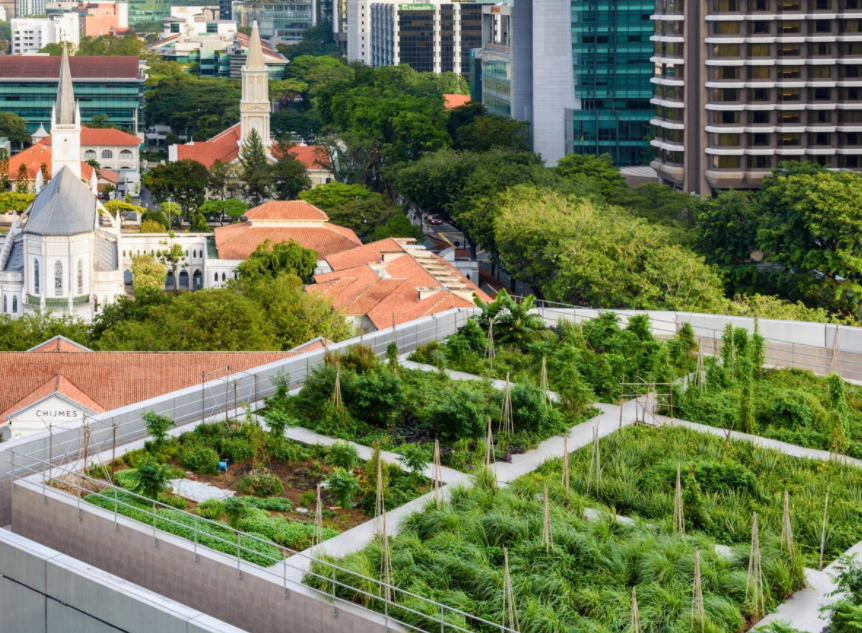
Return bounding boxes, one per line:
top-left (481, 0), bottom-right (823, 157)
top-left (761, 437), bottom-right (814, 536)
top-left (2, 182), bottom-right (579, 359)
top-left (347, 0), bottom-right (483, 78)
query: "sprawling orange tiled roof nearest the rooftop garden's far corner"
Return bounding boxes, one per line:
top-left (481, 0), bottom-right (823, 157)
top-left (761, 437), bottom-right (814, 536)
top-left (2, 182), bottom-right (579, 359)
top-left (306, 238), bottom-right (489, 329)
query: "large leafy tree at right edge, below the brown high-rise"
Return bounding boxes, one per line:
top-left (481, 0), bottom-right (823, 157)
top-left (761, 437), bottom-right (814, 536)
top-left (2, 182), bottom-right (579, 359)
top-left (757, 163), bottom-right (862, 316)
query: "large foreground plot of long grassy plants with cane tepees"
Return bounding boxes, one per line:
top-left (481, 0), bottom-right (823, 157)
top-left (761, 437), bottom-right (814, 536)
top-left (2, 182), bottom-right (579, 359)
top-left (306, 446), bottom-right (803, 633)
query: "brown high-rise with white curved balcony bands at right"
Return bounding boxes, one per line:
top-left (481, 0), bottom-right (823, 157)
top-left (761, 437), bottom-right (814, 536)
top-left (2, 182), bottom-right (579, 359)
top-left (652, 0), bottom-right (862, 195)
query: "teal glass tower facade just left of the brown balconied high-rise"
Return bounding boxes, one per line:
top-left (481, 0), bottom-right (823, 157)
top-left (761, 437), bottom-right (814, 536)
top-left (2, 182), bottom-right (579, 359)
top-left (571, 0), bottom-right (655, 167)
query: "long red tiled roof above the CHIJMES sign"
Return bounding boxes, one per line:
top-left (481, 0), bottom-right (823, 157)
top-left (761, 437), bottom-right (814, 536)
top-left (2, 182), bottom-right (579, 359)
top-left (0, 351), bottom-right (296, 422)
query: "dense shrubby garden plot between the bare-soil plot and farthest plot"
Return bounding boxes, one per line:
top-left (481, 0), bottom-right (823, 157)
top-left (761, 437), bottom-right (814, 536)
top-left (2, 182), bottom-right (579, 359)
top-left (265, 345), bottom-right (594, 471)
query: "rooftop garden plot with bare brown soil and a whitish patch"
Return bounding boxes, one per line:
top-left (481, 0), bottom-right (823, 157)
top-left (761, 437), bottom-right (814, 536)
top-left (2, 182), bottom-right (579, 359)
top-left (73, 414), bottom-right (430, 565)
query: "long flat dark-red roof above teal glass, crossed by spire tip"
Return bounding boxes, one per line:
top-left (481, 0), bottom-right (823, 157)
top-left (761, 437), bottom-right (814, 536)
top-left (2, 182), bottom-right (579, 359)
top-left (0, 55), bottom-right (138, 81)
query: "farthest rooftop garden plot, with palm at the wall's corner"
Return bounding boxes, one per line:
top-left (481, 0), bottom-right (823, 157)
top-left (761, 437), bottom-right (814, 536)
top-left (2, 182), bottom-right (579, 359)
top-left (410, 292), bottom-right (697, 402)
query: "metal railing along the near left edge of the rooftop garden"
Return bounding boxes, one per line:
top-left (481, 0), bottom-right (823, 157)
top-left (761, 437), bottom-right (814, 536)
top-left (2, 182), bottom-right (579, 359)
top-left (10, 450), bottom-right (516, 633)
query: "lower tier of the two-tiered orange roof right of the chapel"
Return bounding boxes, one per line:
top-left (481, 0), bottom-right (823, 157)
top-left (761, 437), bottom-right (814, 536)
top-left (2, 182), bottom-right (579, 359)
top-left (215, 222), bottom-right (361, 259)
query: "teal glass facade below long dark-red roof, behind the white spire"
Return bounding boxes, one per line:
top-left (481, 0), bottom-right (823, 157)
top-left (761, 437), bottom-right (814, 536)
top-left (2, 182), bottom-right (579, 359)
top-left (0, 79), bottom-right (144, 134)
